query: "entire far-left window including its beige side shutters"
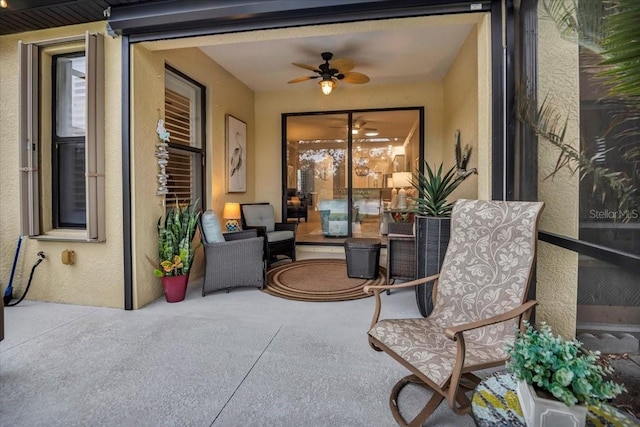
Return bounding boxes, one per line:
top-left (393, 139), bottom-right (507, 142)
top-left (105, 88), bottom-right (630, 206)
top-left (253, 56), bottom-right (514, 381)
top-left (19, 33), bottom-right (105, 241)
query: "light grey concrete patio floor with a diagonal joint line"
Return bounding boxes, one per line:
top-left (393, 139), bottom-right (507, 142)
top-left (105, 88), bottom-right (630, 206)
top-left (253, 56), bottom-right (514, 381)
top-left (0, 251), bottom-right (636, 427)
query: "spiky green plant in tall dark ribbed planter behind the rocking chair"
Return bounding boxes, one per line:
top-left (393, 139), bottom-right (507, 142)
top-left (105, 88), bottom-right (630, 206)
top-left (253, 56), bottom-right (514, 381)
top-left (411, 130), bottom-right (478, 317)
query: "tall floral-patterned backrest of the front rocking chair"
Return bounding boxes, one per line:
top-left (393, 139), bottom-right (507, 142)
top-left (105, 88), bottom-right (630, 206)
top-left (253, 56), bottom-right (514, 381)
top-left (430, 199), bottom-right (544, 343)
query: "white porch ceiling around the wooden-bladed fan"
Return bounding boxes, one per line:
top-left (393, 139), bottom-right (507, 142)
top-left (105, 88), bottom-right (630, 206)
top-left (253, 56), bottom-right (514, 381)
top-left (200, 19), bottom-right (473, 91)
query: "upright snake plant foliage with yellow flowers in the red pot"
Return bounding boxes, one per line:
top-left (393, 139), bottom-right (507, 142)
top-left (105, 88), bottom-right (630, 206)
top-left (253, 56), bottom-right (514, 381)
top-left (153, 201), bottom-right (200, 277)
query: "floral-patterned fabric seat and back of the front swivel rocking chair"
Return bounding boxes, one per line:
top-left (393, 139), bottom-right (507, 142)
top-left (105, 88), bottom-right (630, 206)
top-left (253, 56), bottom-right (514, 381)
top-left (369, 200), bottom-right (542, 386)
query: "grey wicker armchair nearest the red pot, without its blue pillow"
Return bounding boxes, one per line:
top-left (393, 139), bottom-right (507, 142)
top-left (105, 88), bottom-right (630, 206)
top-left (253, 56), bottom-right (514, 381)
top-left (199, 224), bottom-right (266, 296)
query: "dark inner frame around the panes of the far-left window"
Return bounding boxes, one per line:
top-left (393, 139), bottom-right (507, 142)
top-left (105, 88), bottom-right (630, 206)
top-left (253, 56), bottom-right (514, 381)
top-left (51, 51), bottom-right (87, 230)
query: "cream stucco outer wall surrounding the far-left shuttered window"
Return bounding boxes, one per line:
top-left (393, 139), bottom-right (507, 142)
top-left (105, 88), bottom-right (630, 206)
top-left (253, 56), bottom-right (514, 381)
top-left (0, 23), bottom-right (124, 307)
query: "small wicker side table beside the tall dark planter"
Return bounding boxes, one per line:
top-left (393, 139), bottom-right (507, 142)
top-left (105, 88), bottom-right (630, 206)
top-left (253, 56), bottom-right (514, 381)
top-left (387, 222), bottom-right (416, 294)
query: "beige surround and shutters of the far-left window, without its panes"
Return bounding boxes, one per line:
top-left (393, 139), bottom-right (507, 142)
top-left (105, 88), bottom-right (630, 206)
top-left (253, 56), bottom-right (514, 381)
top-left (18, 32), bottom-right (106, 242)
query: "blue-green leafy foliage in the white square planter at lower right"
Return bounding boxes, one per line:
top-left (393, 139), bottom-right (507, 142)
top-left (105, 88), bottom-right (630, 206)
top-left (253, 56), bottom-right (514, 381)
top-left (506, 323), bottom-right (625, 406)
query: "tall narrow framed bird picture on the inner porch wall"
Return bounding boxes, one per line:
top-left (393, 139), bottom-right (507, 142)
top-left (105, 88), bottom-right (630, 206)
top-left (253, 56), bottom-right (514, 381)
top-left (226, 114), bottom-right (247, 193)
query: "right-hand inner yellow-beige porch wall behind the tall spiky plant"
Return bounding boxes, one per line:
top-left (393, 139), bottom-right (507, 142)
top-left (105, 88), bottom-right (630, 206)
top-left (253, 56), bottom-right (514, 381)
top-left (444, 24), bottom-right (480, 199)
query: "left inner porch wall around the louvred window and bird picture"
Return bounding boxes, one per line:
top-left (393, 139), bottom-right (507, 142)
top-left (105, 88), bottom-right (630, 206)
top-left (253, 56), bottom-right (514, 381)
top-left (131, 45), bottom-right (257, 308)
